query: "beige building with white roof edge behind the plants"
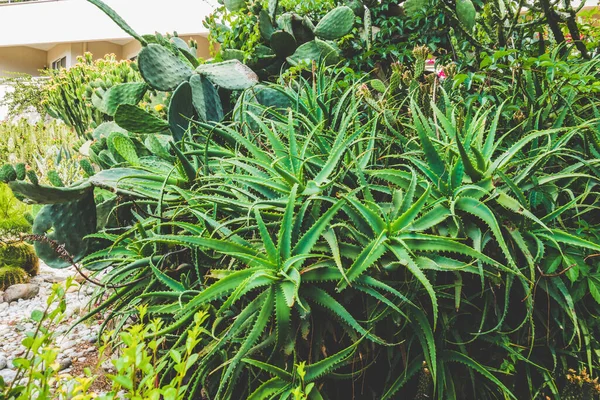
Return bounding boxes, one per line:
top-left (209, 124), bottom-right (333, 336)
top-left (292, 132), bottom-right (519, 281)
top-left (0, 0), bottom-right (215, 117)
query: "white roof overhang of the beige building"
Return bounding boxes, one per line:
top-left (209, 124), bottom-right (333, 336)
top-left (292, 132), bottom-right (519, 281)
top-left (0, 0), bottom-right (215, 48)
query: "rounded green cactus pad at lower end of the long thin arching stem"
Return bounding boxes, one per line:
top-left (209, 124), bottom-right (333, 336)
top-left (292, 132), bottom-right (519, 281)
top-left (138, 44), bottom-right (193, 92)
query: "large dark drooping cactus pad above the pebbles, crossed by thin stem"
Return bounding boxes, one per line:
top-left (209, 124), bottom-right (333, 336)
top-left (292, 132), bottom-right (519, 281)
top-left (33, 189), bottom-right (96, 268)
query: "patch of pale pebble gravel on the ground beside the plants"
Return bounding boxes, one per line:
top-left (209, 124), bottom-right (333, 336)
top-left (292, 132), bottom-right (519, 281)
top-left (0, 262), bottom-right (98, 382)
